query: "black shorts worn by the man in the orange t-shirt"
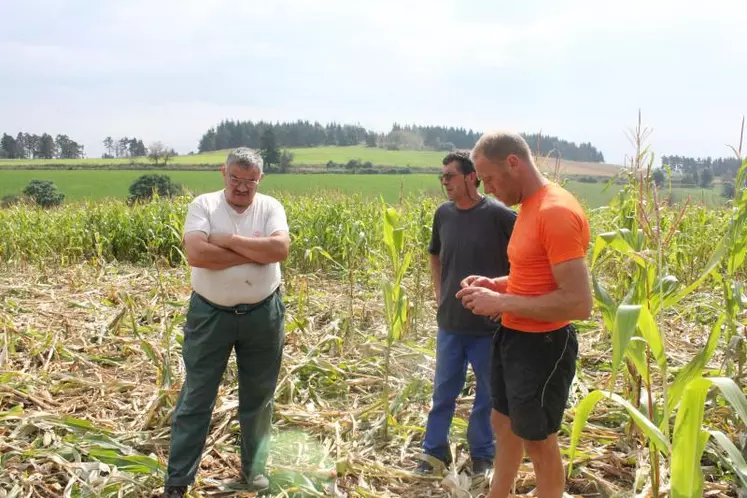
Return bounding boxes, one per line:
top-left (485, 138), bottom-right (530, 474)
top-left (490, 325), bottom-right (578, 441)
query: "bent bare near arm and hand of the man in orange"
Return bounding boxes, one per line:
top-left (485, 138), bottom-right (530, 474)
top-left (457, 258), bottom-right (592, 322)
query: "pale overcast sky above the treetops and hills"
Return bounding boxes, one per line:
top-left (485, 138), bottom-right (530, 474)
top-left (0, 0), bottom-right (747, 163)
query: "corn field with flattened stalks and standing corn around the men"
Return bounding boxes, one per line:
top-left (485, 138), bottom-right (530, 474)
top-left (0, 153), bottom-right (747, 498)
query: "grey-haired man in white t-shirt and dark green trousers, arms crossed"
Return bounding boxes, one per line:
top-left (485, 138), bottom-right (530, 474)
top-left (164, 147), bottom-right (290, 498)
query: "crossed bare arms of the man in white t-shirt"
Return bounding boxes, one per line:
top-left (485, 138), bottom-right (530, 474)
top-left (184, 232), bottom-right (290, 270)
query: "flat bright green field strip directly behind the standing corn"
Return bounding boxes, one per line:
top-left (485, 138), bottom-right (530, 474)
top-left (0, 170), bottom-right (723, 208)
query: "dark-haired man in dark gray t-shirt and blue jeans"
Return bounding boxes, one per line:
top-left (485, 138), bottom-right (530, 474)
top-left (418, 153), bottom-right (516, 474)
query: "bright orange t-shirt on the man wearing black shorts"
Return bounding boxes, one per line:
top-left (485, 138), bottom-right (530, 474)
top-left (502, 183), bottom-right (590, 332)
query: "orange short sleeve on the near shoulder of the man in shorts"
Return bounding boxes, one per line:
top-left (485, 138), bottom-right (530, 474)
top-left (540, 206), bottom-right (589, 265)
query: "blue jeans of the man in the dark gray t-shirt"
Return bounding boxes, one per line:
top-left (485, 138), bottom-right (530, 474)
top-left (423, 329), bottom-right (495, 461)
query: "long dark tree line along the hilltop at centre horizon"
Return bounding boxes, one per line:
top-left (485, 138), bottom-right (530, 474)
top-left (198, 120), bottom-right (604, 162)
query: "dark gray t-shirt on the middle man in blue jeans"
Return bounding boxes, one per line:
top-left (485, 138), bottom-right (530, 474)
top-left (428, 196), bottom-right (516, 335)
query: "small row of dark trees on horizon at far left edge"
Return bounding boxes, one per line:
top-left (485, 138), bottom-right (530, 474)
top-left (0, 132), bottom-right (85, 159)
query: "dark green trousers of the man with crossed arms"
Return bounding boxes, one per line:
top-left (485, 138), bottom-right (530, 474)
top-left (166, 291), bottom-right (285, 486)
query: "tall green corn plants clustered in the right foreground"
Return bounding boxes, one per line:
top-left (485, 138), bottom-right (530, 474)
top-left (569, 115), bottom-right (747, 497)
